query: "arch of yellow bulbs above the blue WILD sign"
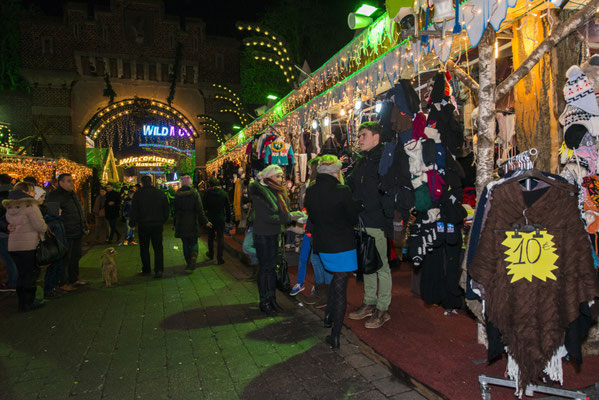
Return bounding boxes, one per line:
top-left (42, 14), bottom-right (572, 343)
top-left (82, 98), bottom-right (199, 141)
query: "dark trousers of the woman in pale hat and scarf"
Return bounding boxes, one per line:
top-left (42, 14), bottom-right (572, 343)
top-left (254, 235), bottom-right (279, 304)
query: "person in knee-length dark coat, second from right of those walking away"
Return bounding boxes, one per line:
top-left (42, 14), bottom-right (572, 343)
top-left (173, 177), bottom-right (208, 270)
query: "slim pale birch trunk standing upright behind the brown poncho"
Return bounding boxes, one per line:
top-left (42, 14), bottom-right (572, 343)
top-left (476, 25), bottom-right (496, 195)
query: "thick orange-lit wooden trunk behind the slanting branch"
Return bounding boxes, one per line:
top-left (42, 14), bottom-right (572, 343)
top-left (512, 13), bottom-right (559, 172)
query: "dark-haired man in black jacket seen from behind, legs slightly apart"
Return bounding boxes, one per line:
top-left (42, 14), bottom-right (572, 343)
top-left (129, 175), bottom-right (169, 278)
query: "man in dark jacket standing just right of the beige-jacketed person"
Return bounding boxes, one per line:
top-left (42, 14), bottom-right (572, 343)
top-left (46, 174), bottom-right (89, 291)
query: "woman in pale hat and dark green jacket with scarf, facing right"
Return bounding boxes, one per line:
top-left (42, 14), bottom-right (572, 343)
top-left (249, 165), bottom-right (303, 315)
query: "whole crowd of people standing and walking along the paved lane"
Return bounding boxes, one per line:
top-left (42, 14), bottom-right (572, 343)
top-left (0, 122), bottom-right (436, 348)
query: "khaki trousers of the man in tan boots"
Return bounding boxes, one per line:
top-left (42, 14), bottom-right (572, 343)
top-left (364, 228), bottom-right (391, 311)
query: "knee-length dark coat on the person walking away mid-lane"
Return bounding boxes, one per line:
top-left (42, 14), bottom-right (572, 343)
top-left (173, 185), bottom-right (208, 238)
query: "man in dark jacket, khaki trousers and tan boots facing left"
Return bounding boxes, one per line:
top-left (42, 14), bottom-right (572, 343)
top-left (346, 122), bottom-right (393, 328)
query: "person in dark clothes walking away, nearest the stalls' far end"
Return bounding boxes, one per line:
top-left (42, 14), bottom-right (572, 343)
top-left (204, 178), bottom-right (231, 264)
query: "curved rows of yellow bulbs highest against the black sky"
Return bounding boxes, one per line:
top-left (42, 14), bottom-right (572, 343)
top-left (236, 23), bottom-right (295, 83)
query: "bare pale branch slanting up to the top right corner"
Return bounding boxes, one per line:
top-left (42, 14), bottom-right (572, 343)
top-left (495, 0), bottom-right (599, 100)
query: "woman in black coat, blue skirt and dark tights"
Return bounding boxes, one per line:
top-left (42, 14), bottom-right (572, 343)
top-left (305, 155), bottom-right (359, 349)
